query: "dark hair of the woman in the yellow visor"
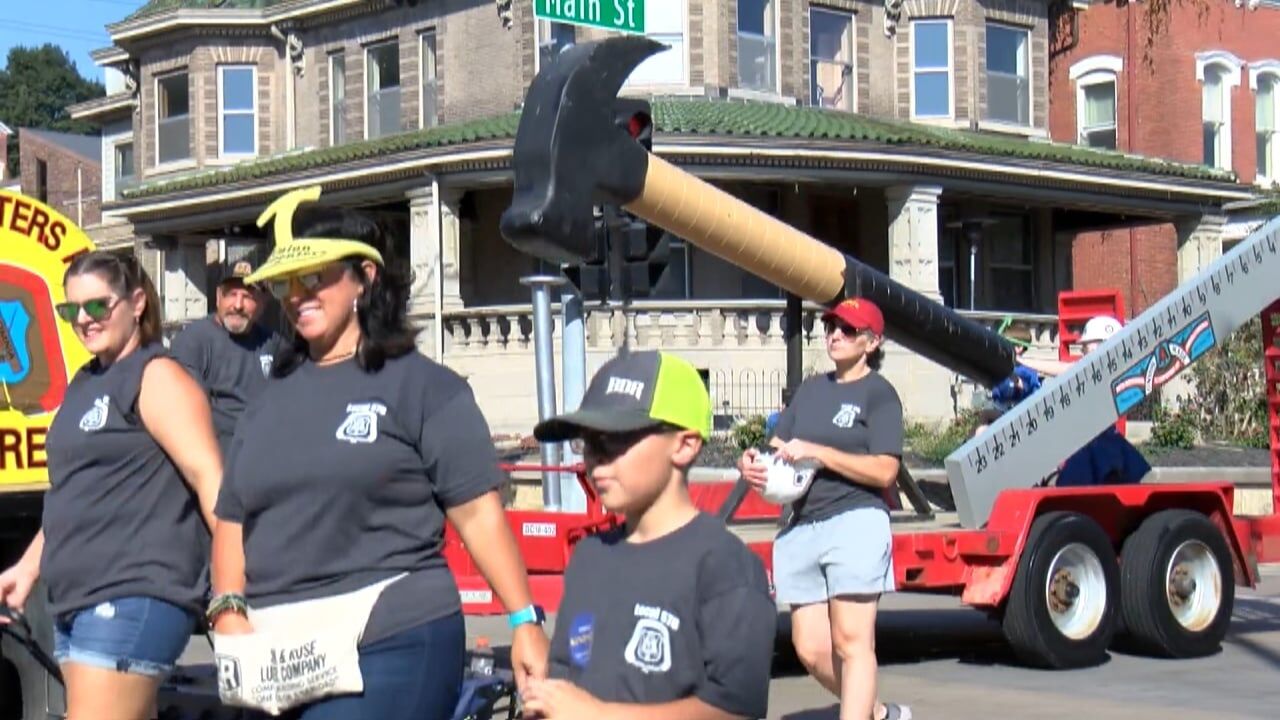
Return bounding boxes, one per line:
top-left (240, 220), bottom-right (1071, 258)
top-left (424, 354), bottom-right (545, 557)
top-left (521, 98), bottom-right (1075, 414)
top-left (271, 208), bottom-right (417, 378)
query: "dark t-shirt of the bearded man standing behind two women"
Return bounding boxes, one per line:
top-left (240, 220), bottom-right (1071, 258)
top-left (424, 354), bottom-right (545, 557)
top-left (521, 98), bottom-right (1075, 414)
top-left (169, 315), bottom-right (284, 451)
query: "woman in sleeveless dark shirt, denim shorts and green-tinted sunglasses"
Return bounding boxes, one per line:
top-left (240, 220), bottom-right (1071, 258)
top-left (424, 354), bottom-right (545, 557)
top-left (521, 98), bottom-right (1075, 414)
top-left (0, 251), bottom-right (221, 720)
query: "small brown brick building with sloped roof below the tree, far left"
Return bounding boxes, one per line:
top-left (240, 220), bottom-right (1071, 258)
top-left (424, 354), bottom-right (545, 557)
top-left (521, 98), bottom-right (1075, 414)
top-left (18, 128), bottom-right (102, 228)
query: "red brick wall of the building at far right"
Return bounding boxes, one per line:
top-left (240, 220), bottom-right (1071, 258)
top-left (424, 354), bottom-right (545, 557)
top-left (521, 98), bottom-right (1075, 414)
top-left (1050, 3), bottom-right (1280, 313)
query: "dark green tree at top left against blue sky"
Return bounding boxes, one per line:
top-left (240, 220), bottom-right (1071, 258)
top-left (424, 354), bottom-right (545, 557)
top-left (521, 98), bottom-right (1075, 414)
top-left (0, 44), bottom-right (106, 172)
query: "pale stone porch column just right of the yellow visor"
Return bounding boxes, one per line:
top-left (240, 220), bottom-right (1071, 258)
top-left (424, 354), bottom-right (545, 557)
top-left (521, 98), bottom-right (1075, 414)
top-left (406, 184), bottom-right (462, 315)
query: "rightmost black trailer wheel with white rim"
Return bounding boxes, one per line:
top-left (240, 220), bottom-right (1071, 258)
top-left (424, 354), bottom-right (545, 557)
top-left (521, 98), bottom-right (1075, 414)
top-left (1120, 510), bottom-right (1235, 657)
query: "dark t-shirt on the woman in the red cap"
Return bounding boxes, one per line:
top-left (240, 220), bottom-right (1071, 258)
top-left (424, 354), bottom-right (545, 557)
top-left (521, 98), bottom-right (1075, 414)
top-left (773, 372), bottom-right (902, 523)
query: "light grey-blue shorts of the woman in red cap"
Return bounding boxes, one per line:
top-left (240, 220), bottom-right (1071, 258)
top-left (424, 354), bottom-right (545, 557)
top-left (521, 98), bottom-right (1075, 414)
top-left (773, 507), bottom-right (895, 605)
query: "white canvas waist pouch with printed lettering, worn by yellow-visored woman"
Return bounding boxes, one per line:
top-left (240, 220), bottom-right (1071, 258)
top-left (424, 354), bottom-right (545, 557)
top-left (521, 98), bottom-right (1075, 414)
top-left (210, 573), bottom-right (404, 715)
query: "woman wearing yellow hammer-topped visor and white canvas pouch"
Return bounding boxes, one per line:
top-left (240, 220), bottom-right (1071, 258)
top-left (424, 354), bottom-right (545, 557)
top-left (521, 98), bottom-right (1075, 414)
top-left (209, 188), bottom-right (548, 720)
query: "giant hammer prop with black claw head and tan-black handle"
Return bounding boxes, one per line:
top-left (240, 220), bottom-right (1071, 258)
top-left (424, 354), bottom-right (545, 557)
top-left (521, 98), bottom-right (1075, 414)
top-left (500, 36), bottom-right (1015, 387)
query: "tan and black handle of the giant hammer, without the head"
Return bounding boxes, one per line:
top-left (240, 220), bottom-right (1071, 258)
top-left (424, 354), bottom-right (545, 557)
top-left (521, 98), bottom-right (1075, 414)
top-left (623, 154), bottom-right (1015, 387)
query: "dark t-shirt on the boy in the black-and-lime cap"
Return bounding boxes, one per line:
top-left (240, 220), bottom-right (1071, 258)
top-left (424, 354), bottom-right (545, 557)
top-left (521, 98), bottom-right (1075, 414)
top-left (550, 514), bottom-right (777, 717)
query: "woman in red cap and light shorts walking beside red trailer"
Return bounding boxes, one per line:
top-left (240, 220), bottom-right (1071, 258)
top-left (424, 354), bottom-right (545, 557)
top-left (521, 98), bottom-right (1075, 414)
top-left (739, 299), bottom-right (911, 720)
